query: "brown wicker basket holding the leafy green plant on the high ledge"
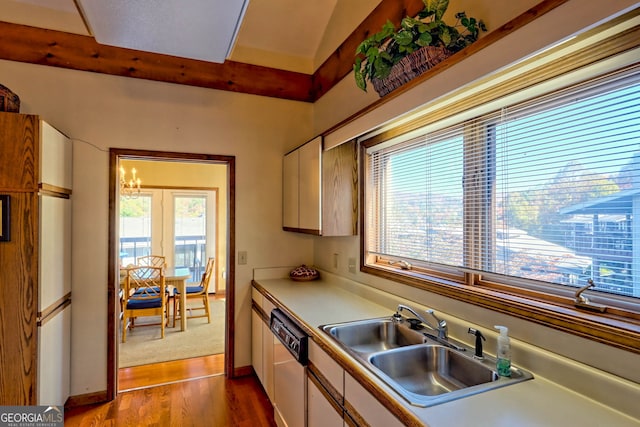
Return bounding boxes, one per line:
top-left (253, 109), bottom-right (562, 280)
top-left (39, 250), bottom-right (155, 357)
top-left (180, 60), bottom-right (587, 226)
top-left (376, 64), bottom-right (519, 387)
top-left (371, 46), bottom-right (451, 97)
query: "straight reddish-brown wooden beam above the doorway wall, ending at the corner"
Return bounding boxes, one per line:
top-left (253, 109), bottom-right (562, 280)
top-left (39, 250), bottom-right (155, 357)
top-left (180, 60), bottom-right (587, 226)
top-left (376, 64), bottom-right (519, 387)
top-left (0, 22), bottom-right (314, 102)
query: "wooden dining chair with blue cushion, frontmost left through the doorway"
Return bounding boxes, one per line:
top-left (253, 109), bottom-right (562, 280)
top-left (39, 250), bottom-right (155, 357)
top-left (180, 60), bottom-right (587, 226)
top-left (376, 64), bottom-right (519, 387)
top-left (122, 266), bottom-right (168, 342)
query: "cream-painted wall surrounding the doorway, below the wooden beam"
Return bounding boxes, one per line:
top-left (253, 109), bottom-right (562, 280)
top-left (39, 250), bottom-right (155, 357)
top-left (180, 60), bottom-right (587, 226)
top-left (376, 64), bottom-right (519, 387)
top-left (0, 61), bottom-right (313, 396)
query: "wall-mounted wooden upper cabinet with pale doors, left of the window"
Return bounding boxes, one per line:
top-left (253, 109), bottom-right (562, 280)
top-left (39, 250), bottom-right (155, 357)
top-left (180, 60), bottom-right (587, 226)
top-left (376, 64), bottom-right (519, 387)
top-left (282, 136), bottom-right (358, 236)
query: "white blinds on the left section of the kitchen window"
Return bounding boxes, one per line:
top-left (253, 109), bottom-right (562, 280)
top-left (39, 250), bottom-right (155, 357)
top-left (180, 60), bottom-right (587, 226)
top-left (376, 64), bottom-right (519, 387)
top-left (367, 126), bottom-right (463, 266)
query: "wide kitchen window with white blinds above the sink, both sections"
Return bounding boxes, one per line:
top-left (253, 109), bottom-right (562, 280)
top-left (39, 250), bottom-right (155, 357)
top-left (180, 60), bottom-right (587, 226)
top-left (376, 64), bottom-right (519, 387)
top-left (364, 66), bottom-right (640, 311)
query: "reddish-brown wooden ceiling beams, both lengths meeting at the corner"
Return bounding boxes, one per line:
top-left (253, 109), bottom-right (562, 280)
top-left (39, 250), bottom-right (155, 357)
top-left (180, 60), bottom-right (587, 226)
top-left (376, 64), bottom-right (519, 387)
top-left (0, 0), bottom-right (424, 102)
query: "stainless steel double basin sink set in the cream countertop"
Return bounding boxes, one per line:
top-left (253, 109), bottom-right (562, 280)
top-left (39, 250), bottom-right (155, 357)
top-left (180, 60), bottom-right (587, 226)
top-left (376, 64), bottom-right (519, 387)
top-left (320, 317), bottom-right (533, 407)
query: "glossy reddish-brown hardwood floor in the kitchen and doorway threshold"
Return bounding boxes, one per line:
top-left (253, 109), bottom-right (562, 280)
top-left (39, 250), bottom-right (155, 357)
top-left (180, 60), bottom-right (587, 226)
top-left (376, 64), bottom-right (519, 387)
top-left (64, 355), bottom-right (276, 427)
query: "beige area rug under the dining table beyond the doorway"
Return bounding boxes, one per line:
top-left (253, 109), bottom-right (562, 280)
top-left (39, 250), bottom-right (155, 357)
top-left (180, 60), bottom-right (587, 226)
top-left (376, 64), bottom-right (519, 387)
top-left (118, 299), bottom-right (225, 368)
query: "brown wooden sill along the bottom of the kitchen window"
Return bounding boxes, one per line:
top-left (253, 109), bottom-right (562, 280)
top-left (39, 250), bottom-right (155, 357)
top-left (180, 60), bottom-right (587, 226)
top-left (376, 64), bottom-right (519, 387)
top-left (361, 265), bottom-right (640, 354)
